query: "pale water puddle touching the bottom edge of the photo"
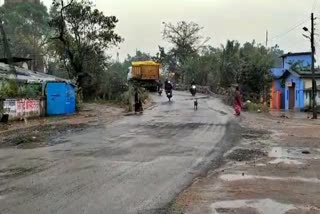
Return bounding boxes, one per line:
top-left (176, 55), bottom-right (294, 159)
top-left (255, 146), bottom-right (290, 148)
top-left (211, 199), bottom-right (297, 214)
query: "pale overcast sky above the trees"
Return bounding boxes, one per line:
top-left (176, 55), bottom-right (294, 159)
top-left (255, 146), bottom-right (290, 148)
top-left (30, 0), bottom-right (320, 59)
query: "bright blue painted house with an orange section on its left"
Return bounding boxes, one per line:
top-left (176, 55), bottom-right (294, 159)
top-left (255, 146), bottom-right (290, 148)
top-left (270, 52), bottom-right (320, 110)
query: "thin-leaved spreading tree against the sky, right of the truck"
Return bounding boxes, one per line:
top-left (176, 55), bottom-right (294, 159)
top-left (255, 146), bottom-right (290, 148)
top-left (160, 21), bottom-right (209, 81)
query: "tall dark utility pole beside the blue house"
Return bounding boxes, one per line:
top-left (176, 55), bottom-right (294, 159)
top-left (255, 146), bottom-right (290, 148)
top-left (311, 13), bottom-right (318, 119)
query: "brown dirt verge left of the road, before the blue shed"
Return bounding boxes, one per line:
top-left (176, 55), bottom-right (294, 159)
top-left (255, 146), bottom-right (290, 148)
top-left (0, 103), bottom-right (124, 149)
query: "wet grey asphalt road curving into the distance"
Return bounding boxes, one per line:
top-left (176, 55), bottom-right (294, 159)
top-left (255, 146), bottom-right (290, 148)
top-left (0, 92), bottom-right (238, 214)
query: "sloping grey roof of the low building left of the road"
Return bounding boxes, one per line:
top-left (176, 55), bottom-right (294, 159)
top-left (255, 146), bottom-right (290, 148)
top-left (0, 63), bottom-right (72, 83)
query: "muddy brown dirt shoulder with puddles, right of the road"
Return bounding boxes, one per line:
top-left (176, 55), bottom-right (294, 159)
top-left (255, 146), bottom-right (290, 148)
top-left (172, 111), bottom-right (320, 214)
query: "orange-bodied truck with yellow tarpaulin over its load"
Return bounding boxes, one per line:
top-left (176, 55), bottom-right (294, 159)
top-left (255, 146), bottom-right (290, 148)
top-left (128, 61), bottom-right (161, 91)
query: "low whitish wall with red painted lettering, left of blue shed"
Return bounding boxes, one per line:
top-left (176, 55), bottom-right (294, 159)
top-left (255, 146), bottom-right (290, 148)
top-left (2, 98), bottom-right (46, 120)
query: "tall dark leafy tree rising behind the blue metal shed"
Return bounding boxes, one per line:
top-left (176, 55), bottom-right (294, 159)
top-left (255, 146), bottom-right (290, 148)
top-left (49, 0), bottom-right (122, 98)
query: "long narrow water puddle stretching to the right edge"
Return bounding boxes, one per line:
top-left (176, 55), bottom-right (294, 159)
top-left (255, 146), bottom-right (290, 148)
top-left (220, 174), bottom-right (320, 183)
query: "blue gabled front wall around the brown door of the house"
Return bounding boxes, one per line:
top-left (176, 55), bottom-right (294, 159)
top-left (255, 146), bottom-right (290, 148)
top-left (285, 74), bottom-right (304, 110)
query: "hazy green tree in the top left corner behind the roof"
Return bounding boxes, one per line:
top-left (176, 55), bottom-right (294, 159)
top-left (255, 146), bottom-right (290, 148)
top-left (0, 2), bottom-right (50, 71)
